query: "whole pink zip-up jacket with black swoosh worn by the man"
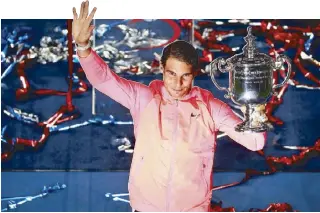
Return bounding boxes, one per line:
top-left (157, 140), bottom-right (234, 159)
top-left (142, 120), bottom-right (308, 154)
top-left (80, 51), bottom-right (266, 212)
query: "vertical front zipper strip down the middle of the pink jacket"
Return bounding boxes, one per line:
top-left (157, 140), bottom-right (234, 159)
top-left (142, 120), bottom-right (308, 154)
top-left (166, 100), bottom-right (179, 212)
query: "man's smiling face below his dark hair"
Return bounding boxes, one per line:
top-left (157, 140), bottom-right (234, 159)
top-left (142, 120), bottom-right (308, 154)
top-left (162, 57), bottom-right (194, 99)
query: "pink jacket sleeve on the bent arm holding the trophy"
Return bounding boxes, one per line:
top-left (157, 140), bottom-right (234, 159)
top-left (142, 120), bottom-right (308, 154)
top-left (210, 98), bottom-right (267, 151)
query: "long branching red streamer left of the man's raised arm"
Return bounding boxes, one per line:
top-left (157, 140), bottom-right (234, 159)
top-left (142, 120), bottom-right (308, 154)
top-left (1, 20), bottom-right (88, 161)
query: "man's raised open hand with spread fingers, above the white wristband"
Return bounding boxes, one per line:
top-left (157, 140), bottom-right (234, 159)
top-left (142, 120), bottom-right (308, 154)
top-left (72, 0), bottom-right (97, 46)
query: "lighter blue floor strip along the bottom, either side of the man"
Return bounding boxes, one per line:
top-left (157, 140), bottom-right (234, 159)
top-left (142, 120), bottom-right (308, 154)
top-left (1, 171), bottom-right (320, 212)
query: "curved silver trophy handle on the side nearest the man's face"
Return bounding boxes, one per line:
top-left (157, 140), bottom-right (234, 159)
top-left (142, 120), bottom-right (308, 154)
top-left (210, 57), bottom-right (232, 98)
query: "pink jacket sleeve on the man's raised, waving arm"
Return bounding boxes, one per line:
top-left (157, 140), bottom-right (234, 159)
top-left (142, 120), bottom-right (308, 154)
top-left (78, 50), bottom-right (150, 112)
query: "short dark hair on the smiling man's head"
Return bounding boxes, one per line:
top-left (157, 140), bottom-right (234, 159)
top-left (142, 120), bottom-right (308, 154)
top-left (161, 40), bottom-right (199, 71)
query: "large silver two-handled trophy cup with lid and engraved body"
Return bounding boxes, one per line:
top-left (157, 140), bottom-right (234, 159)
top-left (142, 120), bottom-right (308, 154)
top-left (210, 27), bottom-right (291, 132)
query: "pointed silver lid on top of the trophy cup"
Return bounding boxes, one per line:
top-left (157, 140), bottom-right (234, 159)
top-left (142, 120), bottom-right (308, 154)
top-left (231, 26), bottom-right (272, 66)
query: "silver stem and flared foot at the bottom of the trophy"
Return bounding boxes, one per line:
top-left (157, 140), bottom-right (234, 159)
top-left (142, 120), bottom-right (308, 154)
top-left (235, 104), bottom-right (273, 132)
